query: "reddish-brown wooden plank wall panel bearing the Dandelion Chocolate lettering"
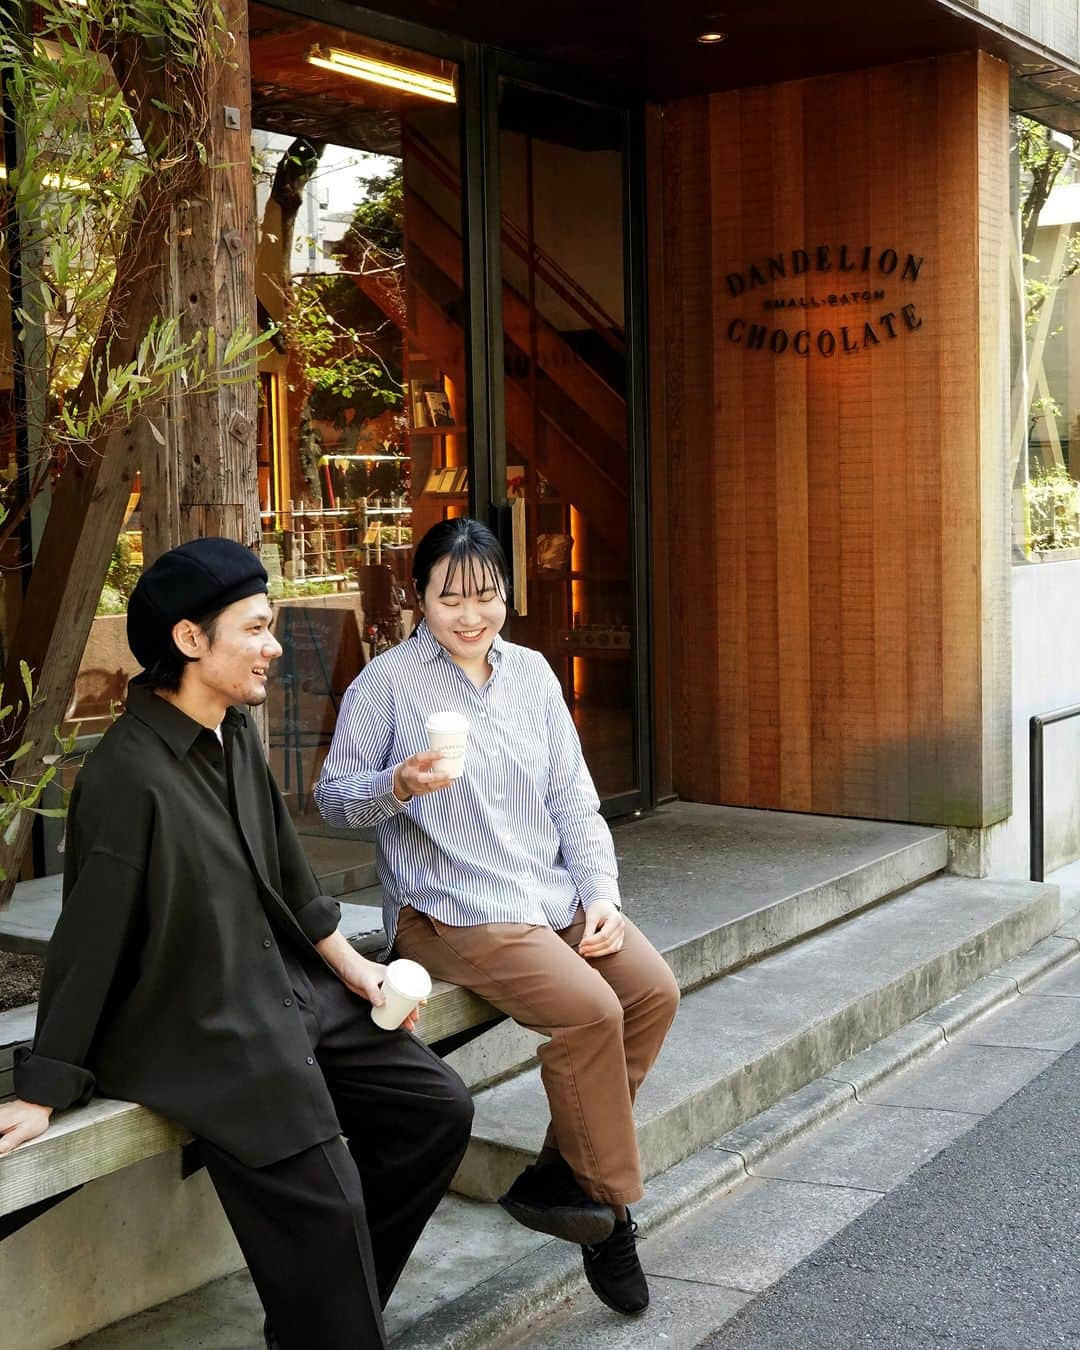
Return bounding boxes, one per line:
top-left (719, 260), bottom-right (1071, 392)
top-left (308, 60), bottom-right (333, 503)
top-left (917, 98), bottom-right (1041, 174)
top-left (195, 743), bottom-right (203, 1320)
top-left (663, 53), bottom-right (1010, 825)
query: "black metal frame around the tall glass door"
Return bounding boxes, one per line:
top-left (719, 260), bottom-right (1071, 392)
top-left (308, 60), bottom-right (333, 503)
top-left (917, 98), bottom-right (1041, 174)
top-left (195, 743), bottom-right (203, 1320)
top-left (262, 0), bottom-right (656, 818)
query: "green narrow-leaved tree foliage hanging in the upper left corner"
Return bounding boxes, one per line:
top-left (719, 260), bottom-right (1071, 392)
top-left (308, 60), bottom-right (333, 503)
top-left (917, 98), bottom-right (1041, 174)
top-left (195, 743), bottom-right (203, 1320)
top-left (0, 0), bottom-right (259, 553)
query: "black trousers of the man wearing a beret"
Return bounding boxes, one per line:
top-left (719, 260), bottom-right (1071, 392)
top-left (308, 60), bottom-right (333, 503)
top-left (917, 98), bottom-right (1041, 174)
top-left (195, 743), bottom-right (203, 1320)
top-left (201, 959), bottom-right (473, 1350)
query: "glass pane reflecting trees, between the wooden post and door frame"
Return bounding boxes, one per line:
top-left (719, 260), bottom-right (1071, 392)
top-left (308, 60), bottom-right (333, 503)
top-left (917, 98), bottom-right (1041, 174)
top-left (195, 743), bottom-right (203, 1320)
top-left (251, 5), bottom-right (468, 834)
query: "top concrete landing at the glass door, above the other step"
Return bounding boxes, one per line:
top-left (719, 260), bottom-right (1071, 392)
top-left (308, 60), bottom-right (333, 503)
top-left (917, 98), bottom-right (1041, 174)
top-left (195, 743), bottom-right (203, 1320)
top-left (448, 802), bottom-right (948, 1089)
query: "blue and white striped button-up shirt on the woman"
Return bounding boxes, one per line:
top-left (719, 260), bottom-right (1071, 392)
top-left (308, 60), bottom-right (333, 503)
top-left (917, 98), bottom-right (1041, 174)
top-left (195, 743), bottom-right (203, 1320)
top-left (315, 622), bottom-right (618, 941)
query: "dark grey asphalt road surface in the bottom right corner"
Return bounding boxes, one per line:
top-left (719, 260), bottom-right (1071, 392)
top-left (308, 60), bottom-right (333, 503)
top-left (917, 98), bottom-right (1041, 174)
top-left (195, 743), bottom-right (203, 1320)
top-left (701, 1046), bottom-right (1080, 1350)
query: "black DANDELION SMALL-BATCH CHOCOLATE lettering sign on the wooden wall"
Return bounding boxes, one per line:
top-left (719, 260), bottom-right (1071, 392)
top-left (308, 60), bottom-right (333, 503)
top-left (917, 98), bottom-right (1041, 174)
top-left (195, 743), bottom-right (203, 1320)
top-left (724, 244), bottom-right (925, 358)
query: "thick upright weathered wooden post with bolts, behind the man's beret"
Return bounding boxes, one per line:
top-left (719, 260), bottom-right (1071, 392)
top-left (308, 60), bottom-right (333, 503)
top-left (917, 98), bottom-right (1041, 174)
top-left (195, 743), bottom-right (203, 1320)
top-left (140, 0), bottom-right (261, 564)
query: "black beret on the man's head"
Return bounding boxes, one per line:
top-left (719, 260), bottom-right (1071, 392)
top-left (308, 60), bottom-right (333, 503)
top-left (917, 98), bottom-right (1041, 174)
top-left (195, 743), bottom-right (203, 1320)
top-left (127, 539), bottom-right (266, 667)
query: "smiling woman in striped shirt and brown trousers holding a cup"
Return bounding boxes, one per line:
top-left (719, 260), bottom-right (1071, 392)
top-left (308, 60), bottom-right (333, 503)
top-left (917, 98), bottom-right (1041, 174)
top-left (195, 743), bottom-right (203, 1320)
top-left (316, 518), bottom-right (679, 1314)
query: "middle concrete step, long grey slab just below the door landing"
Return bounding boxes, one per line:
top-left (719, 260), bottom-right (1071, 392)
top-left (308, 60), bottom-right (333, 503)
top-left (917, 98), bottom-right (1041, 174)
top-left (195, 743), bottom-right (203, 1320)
top-left (454, 876), bottom-right (1060, 1200)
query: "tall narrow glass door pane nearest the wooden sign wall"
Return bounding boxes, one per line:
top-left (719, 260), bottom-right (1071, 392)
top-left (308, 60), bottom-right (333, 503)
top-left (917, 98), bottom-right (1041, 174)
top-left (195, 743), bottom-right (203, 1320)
top-left (498, 78), bottom-right (644, 810)
